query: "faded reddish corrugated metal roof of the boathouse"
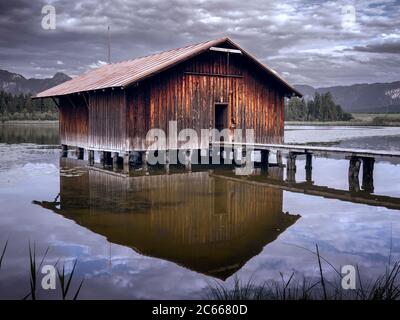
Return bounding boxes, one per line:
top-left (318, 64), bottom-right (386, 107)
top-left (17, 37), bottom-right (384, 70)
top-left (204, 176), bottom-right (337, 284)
top-left (36, 38), bottom-right (302, 98)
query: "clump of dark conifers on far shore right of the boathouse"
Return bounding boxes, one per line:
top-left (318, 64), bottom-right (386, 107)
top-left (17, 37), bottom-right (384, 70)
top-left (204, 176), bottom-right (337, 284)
top-left (285, 92), bottom-right (353, 121)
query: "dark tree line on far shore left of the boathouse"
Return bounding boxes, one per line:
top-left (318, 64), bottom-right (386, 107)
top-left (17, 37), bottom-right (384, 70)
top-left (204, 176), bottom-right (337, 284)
top-left (0, 91), bottom-right (58, 122)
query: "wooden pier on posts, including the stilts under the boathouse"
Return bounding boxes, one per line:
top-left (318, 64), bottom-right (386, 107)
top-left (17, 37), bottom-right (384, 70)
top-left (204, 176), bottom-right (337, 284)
top-left (61, 142), bottom-right (400, 198)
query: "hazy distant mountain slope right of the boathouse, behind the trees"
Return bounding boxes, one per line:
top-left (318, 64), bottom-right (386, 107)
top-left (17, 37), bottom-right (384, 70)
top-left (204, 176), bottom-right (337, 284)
top-left (295, 81), bottom-right (400, 113)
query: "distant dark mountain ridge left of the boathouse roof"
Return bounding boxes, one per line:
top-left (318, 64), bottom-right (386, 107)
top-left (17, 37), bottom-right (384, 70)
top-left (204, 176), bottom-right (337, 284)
top-left (0, 70), bottom-right (71, 95)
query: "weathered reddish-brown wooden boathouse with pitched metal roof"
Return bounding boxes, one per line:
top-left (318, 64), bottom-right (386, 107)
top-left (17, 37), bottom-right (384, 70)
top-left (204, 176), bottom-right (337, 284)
top-left (36, 38), bottom-right (301, 165)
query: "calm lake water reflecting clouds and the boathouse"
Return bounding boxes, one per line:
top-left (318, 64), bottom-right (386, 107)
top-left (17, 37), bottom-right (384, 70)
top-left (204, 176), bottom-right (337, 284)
top-left (0, 125), bottom-right (400, 299)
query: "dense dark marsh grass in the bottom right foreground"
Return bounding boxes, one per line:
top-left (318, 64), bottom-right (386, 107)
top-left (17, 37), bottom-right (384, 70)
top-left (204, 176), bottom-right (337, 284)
top-left (205, 245), bottom-right (400, 300)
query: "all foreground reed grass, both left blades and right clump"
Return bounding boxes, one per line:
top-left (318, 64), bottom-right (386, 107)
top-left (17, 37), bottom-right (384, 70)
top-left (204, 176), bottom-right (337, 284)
top-left (0, 242), bottom-right (400, 300)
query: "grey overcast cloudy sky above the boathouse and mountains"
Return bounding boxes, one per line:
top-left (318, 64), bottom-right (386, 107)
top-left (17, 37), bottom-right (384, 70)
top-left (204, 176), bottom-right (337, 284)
top-left (0, 0), bottom-right (400, 87)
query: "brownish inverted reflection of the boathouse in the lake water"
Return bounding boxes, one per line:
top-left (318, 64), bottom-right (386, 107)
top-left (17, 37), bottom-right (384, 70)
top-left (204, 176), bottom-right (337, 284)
top-left (35, 158), bottom-right (299, 279)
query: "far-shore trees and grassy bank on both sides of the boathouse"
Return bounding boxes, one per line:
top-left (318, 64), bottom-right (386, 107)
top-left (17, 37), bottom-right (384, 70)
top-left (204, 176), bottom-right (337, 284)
top-left (0, 91), bottom-right (400, 127)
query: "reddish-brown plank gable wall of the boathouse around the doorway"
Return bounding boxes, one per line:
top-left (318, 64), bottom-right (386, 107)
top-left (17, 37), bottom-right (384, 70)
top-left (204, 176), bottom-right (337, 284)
top-left (127, 52), bottom-right (284, 149)
